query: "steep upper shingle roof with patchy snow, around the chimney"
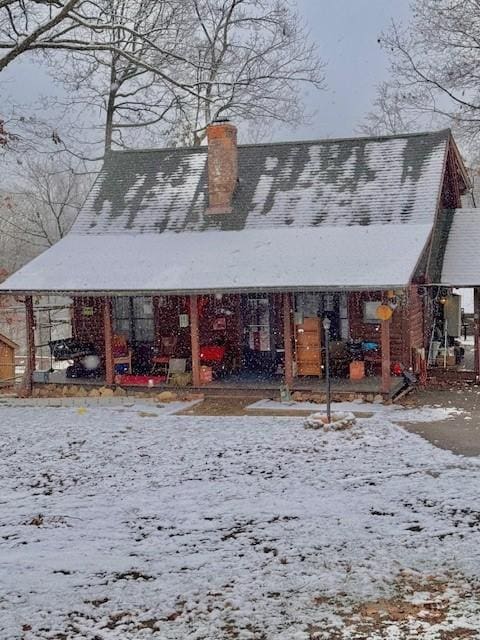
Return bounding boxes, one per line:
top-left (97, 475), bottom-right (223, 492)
top-left (73, 130), bottom-right (450, 234)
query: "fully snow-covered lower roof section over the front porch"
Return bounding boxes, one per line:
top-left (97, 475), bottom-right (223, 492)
top-left (0, 224), bottom-right (431, 294)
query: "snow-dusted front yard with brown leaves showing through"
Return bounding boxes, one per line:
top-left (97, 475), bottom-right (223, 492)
top-left (0, 405), bottom-right (480, 640)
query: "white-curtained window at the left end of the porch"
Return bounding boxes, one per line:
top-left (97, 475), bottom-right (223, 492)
top-left (113, 296), bottom-right (155, 344)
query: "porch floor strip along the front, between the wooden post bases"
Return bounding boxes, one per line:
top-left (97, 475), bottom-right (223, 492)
top-left (34, 371), bottom-right (404, 397)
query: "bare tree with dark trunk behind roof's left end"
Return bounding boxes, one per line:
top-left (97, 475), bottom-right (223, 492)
top-left (43, 0), bottom-right (189, 150)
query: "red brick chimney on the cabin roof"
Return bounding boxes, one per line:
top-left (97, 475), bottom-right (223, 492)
top-left (206, 120), bottom-right (238, 215)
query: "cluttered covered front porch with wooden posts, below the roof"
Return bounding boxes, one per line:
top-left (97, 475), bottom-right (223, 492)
top-left (26, 291), bottom-right (404, 397)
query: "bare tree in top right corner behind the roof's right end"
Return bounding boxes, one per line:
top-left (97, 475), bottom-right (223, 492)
top-left (360, 0), bottom-right (480, 152)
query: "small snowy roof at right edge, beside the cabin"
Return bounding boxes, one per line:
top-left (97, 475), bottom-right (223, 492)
top-left (437, 209), bottom-right (480, 287)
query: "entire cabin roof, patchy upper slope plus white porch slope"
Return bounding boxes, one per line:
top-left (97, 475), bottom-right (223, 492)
top-left (0, 130), bottom-right (450, 293)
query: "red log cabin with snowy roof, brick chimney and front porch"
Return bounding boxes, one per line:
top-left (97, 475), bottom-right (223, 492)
top-left (0, 121), bottom-right (469, 394)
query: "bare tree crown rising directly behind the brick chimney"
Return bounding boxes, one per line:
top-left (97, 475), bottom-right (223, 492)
top-left (162, 0), bottom-right (324, 145)
